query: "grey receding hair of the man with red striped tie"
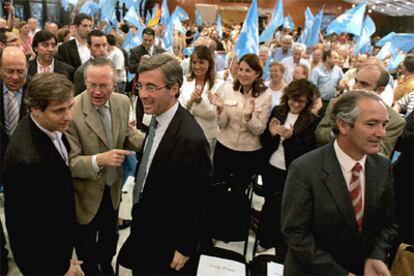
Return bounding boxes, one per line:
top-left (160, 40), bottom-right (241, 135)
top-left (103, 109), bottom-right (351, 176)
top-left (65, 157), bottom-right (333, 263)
top-left (330, 90), bottom-right (385, 135)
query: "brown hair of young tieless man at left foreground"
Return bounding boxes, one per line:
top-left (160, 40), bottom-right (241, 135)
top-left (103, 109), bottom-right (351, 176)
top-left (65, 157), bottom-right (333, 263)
top-left (24, 73), bottom-right (75, 111)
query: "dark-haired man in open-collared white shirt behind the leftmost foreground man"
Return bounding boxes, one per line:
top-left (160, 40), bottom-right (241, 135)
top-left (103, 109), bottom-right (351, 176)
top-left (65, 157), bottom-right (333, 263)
top-left (28, 31), bottom-right (75, 81)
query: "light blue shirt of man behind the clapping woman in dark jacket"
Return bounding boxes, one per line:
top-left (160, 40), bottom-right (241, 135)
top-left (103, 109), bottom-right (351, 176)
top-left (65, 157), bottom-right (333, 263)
top-left (309, 63), bottom-right (344, 101)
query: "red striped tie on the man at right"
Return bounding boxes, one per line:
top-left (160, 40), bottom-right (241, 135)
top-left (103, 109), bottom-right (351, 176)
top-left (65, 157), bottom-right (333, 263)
top-left (350, 162), bottom-right (364, 232)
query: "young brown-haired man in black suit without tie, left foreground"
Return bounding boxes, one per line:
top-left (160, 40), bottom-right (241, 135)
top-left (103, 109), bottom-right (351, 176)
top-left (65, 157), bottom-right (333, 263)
top-left (4, 73), bottom-right (80, 275)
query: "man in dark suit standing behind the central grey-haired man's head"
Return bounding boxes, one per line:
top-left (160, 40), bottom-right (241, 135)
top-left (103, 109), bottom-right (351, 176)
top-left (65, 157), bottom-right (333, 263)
top-left (128, 28), bottom-right (165, 73)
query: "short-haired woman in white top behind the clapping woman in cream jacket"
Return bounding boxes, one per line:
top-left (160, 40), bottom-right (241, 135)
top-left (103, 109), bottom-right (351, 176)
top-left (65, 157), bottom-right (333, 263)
top-left (266, 61), bottom-right (286, 109)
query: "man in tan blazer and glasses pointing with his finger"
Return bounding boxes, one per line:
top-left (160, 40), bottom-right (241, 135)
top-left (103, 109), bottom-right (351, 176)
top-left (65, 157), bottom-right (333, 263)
top-left (67, 58), bottom-right (143, 275)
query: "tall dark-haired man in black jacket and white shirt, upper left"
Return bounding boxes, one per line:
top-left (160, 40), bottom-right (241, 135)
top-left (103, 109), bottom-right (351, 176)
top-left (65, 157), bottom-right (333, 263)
top-left (57, 13), bottom-right (93, 70)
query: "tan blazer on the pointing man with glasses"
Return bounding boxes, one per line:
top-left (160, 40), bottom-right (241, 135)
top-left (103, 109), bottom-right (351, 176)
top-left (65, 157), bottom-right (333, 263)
top-left (66, 91), bottom-right (144, 224)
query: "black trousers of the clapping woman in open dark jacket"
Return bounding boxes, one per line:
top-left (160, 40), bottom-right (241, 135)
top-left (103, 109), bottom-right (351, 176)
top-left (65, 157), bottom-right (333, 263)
top-left (258, 162), bottom-right (287, 259)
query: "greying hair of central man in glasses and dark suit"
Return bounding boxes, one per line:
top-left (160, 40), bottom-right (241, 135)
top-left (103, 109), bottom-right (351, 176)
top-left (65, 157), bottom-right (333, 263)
top-left (138, 53), bottom-right (183, 89)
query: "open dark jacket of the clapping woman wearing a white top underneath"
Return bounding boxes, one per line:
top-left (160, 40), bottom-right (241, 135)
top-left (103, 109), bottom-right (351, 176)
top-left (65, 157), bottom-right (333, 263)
top-left (260, 106), bottom-right (319, 168)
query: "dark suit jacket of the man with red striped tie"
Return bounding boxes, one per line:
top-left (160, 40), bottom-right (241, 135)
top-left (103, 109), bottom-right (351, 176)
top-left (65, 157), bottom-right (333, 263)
top-left (281, 143), bottom-right (398, 275)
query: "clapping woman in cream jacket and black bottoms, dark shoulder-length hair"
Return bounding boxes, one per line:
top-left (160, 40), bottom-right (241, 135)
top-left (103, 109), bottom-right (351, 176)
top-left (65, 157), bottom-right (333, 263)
top-left (209, 54), bottom-right (272, 190)
